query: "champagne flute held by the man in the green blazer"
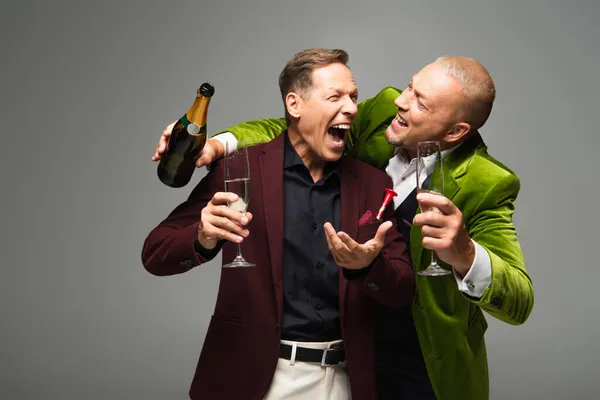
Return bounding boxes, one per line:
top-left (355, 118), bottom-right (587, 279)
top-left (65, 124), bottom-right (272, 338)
top-left (417, 142), bottom-right (451, 276)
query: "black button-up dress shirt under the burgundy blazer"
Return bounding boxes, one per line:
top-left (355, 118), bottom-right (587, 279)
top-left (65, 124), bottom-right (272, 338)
top-left (281, 132), bottom-right (342, 342)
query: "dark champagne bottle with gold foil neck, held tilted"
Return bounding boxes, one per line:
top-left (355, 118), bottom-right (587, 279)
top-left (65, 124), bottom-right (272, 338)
top-left (157, 83), bottom-right (215, 188)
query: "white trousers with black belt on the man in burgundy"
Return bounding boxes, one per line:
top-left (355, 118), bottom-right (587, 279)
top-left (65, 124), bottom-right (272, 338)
top-left (264, 340), bottom-right (352, 400)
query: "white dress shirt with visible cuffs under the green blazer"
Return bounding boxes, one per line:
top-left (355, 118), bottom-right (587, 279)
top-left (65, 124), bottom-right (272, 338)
top-left (214, 132), bottom-right (492, 298)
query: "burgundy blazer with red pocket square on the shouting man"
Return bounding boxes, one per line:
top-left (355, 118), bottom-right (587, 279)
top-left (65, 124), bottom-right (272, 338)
top-left (142, 135), bottom-right (414, 400)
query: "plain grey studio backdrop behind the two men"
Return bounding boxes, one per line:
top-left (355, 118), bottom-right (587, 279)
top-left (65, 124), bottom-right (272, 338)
top-left (0, 0), bottom-right (600, 399)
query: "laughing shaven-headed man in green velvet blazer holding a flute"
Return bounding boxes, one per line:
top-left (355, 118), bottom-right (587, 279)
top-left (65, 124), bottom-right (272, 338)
top-left (153, 57), bottom-right (534, 400)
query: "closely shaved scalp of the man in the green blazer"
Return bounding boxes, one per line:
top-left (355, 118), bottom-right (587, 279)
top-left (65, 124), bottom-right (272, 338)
top-left (434, 56), bottom-right (496, 130)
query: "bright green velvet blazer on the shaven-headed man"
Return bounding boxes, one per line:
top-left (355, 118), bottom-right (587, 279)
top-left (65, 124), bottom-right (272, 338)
top-left (216, 87), bottom-right (534, 400)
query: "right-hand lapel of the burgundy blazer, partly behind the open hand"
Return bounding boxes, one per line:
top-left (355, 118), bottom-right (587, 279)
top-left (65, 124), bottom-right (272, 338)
top-left (339, 155), bottom-right (360, 320)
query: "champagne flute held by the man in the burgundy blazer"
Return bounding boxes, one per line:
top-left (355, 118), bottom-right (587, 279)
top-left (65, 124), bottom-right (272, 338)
top-left (223, 140), bottom-right (255, 268)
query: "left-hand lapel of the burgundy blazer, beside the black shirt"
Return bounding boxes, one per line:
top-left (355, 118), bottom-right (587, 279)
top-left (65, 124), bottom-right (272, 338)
top-left (259, 135), bottom-right (284, 325)
